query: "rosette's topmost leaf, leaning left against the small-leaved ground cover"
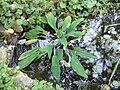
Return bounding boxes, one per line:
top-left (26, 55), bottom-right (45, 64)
top-left (46, 13), bottom-right (57, 30)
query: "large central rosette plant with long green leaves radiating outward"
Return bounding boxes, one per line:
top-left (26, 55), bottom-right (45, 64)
top-left (18, 13), bottom-right (94, 81)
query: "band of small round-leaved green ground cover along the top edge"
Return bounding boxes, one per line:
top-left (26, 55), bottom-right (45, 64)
top-left (0, 0), bottom-right (113, 30)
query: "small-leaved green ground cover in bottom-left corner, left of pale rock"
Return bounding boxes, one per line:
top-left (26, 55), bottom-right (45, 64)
top-left (0, 64), bottom-right (22, 90)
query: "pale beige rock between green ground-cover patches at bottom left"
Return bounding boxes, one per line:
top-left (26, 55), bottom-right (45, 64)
top-left (13, 72), bottom-right (33, 90)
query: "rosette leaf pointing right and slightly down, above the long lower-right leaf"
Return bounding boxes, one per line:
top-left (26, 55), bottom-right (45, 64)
top-left (74, 47), bottom-right (95, 59)
